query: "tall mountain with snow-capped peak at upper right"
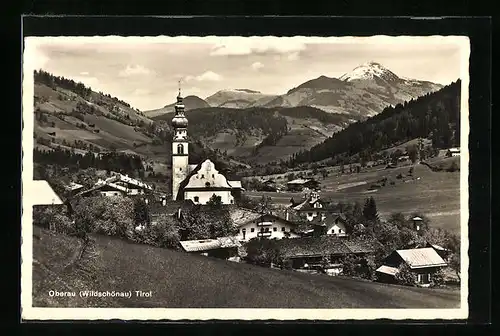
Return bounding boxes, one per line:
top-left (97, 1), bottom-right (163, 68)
top-left (262, 62), bottom-right (443, 117)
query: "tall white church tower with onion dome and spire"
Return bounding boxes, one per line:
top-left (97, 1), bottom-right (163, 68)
top-left (172, 81), bottom-right (189, 201)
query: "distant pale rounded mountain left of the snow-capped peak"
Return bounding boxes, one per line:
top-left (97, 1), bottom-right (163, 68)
top-left (205, 89), bottom-right (276, 108)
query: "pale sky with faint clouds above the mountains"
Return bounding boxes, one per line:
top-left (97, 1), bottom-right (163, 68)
top-left (25, 37), bottom-right (468, 111)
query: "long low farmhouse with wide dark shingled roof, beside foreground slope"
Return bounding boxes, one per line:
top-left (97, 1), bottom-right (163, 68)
top-left (276, 236), bottom-right (378, 275)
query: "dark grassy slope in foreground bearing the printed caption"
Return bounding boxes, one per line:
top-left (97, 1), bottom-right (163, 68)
top-left (33, 227), bottom-right (460, 308)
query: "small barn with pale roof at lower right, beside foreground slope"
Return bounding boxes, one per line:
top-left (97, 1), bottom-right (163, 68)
top-left (376, 247), bottom-right (447, 287)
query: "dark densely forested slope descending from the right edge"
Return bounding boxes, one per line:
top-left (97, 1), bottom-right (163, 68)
top-left (288, 80), bottom-right (461, 167)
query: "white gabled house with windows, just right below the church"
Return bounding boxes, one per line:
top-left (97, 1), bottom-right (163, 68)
top-left (230, 208), bottom-right (300, 241)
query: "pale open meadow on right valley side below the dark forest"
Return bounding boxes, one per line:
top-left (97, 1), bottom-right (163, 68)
top-left (246, 158), bottom-right (460, 234)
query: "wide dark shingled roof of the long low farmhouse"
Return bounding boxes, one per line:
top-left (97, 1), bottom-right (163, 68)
top-left (276, 236), bottom-right (379, 258)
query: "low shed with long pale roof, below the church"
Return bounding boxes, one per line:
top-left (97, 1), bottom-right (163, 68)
top-left (180, 237), bottom-right (241, 261)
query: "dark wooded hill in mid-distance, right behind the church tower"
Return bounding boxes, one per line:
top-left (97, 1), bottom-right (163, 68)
top-left (153, 106), bottom-right (350, 164)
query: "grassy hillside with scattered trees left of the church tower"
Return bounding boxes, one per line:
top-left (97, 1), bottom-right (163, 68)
top-left (33, 70), bottom-right (243, 177)
